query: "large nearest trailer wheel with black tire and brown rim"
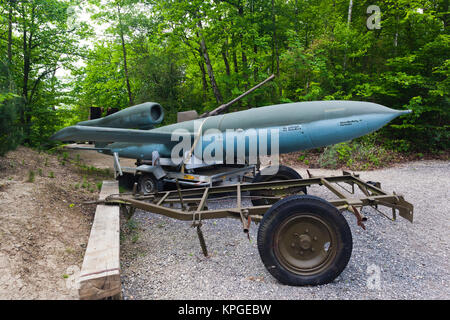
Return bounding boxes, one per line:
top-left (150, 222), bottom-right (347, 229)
top-left (258, 195), bottom-right (353, 286)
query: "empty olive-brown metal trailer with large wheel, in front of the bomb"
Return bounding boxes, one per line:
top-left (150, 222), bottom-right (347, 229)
top-left (100, 171), bottom-right (413, 286)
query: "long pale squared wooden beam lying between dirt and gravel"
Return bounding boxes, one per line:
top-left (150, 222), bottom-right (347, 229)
top-left (78, 181), bottom-right (121, 300)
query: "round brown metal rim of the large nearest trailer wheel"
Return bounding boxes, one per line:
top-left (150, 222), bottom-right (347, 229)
top-left (274, 214), bottom-right (337, 275)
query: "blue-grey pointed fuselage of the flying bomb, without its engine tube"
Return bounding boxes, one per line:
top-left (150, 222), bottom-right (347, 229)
top-left (51, 101), bottom-right (410, 160)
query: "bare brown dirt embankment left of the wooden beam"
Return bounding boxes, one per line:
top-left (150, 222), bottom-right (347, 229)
top-left (0, 147), bottom-right (110, 299)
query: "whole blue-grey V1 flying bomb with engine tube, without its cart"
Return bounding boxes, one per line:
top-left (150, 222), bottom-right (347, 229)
top-left (52, 101), bottom-right (411, 164)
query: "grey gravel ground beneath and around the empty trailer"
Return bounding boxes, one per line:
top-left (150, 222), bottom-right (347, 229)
top-left (122, 161), bottom-right (450, 300)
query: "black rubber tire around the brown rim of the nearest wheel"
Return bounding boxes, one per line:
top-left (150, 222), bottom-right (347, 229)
top-left (258, 195), bottom-right (353, 286)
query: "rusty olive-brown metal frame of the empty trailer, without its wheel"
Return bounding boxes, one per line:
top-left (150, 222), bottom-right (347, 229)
top-left (104, 175), bottom-right (413, 225)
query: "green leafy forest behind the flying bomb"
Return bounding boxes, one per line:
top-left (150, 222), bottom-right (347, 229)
top-left (0, 0), bottom-right (450, 160)
